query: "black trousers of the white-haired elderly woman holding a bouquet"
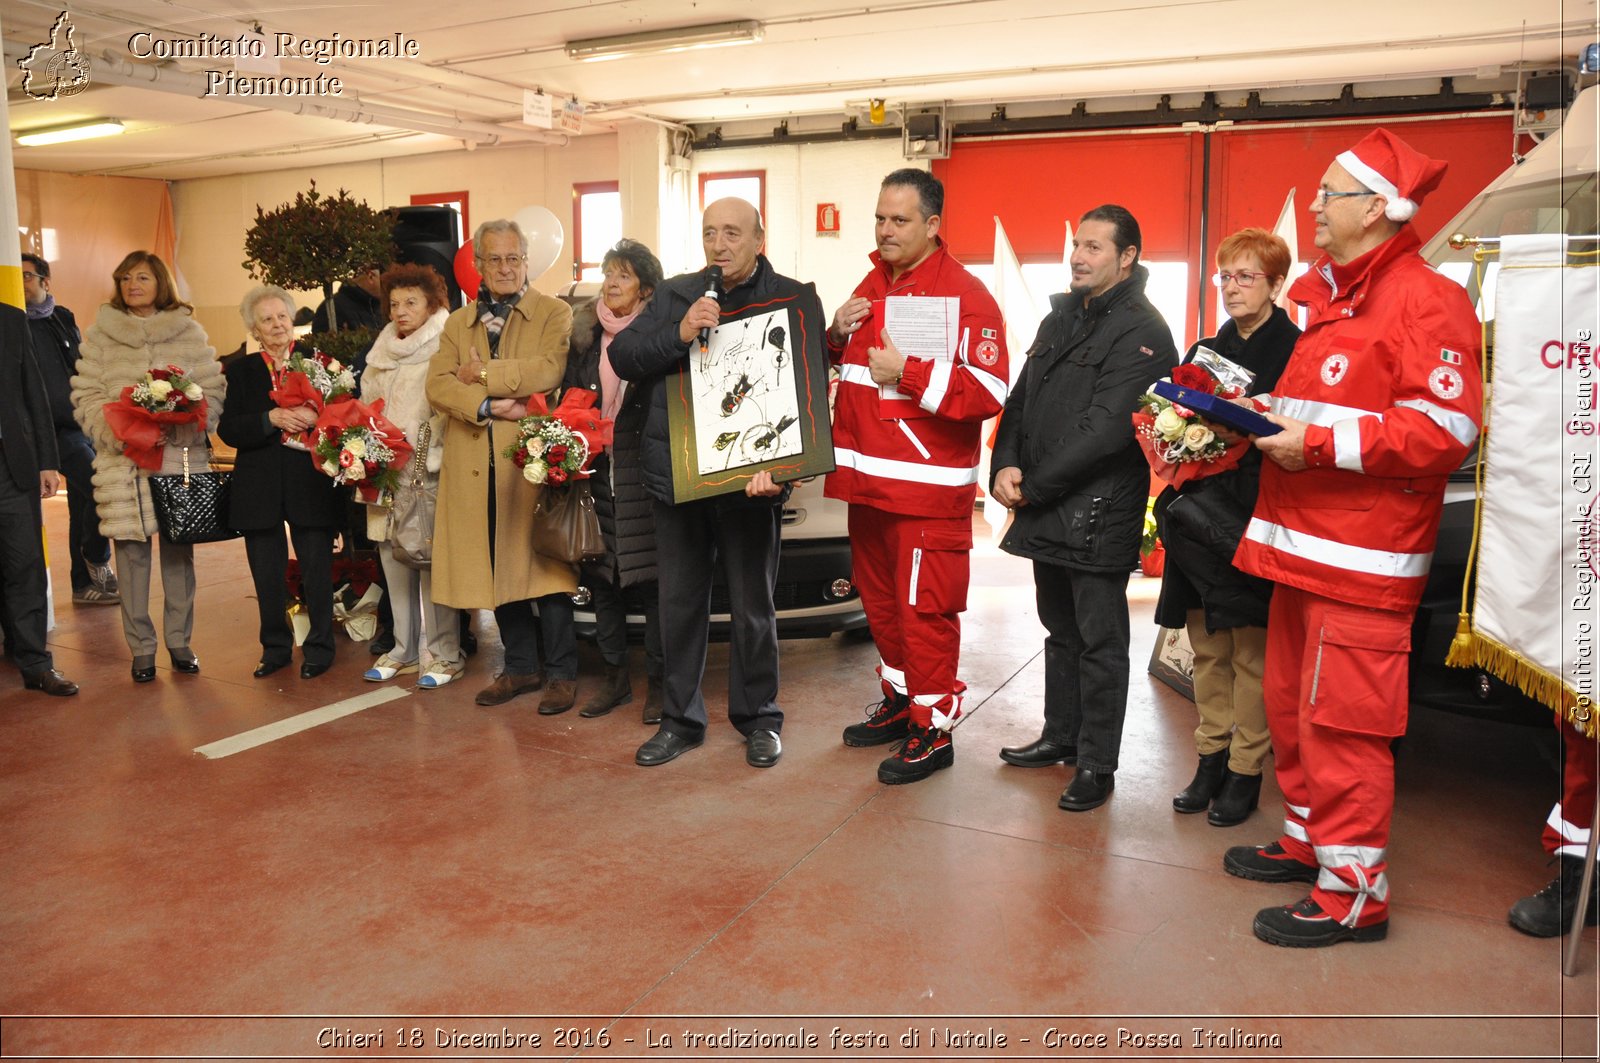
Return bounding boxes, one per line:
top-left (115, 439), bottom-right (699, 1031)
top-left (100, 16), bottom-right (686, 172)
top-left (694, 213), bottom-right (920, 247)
top-left (245, 523), bottom-right (336, 664)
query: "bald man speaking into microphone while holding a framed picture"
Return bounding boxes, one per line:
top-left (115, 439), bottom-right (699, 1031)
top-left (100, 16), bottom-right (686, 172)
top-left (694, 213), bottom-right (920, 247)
top-left (610, 199), bottom-right (827, 768)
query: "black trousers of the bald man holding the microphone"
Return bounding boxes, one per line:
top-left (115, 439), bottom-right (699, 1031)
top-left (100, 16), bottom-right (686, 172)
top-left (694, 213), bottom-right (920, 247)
top-left (653, 496), bottom-right (784, 738)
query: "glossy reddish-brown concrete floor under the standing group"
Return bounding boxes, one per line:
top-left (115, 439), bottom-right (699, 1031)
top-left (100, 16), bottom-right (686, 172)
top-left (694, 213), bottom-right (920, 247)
top-left (0, 499), bottom-right (1600, 1060)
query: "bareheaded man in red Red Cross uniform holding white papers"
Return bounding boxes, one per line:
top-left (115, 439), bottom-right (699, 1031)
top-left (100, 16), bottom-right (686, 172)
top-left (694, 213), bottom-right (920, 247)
top-left (826, 170), bottom-right (1010, 783)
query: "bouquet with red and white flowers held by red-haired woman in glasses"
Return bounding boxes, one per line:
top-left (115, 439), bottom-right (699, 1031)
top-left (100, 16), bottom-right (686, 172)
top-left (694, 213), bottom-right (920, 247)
top-left (1133, 347), bottom-right (1266, 487)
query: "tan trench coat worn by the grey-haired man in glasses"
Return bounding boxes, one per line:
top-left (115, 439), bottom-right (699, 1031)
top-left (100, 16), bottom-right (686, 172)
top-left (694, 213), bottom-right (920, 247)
top-left (427, 288), bottom-right (578, 608)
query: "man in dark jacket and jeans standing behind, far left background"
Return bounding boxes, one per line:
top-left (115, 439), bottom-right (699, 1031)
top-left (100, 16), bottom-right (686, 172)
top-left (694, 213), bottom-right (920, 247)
top-left (22, 255), bottom-right (118, 605)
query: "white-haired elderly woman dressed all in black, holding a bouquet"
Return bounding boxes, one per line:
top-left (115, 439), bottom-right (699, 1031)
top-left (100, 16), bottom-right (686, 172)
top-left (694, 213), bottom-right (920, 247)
top-left (216, 285), bottom-right (344, 679)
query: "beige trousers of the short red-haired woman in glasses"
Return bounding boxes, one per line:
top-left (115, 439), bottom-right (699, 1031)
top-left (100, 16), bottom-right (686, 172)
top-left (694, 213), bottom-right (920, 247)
top-left (1187, 608), bottom-right (1272, 775)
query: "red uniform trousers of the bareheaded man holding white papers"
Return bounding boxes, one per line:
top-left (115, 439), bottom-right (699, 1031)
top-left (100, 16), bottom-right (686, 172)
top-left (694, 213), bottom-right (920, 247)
top-left (850, 504), bottom-right (973, 730)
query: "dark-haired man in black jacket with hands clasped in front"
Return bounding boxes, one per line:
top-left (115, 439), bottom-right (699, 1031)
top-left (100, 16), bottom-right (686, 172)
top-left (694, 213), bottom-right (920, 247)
top-left (990, 205), bottom-right (1178, 812)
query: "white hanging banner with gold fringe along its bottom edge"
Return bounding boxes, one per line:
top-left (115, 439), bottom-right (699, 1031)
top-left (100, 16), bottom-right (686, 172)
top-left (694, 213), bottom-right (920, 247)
top-left (1450, 235), bottom-right (1600, 736)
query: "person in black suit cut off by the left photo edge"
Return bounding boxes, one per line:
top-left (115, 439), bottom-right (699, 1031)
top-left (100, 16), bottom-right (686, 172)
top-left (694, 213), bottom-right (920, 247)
top-left (0, 304), bottom-right (78, 698)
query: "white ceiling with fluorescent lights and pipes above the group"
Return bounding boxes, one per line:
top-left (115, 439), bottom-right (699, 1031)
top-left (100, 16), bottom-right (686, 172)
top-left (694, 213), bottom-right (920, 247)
top-left (0, 0), bottom-right (1597, 178)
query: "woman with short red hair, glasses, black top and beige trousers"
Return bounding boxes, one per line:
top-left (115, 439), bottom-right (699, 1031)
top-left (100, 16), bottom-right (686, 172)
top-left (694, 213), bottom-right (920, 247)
top-left (1155, 229), bottom-right (1299, 826)
